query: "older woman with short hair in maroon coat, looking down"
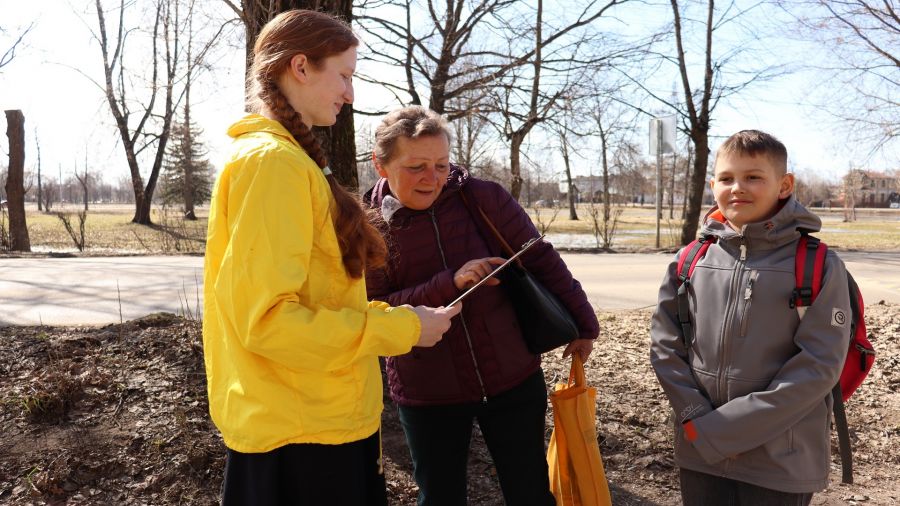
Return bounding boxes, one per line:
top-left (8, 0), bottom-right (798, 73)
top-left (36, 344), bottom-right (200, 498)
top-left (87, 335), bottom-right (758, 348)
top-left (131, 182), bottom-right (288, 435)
top-left (365, 106), bottom-right (599, 506)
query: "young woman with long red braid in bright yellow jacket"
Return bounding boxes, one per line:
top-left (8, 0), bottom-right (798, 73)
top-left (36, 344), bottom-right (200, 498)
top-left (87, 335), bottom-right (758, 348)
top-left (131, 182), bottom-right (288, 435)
top-left (203, 10), bottom-right (459, 505)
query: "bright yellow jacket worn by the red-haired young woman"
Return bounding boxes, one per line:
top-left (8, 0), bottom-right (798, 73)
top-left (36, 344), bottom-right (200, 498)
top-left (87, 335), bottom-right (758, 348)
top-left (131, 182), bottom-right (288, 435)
top-left (203, 115), bottom-right (420, 453)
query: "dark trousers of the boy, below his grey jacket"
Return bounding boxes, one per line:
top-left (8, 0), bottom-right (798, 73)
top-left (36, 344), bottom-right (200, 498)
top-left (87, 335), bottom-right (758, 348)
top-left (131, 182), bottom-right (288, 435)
top-left (681, 469), bottom-right (812, 506)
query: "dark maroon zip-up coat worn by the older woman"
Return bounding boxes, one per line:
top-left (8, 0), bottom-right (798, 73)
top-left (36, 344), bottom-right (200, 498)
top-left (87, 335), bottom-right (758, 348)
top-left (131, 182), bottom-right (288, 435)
top-left (365, 166), bottom-right (599, 406)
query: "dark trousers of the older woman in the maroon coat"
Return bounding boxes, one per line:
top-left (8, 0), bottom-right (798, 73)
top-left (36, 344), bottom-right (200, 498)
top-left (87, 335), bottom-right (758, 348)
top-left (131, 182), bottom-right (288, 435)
top-left (399, 371), bottom-right (556, 506)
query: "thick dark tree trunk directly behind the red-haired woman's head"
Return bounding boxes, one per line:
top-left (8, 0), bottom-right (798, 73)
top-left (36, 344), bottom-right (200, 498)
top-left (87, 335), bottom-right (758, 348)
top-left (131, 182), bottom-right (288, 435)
top-left (241, 0), bottom-right (359, 191)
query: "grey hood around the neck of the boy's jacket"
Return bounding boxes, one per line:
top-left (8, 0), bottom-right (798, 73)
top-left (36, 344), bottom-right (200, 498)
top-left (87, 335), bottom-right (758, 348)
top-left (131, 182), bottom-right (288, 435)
top-left (700, 195), bottom-right (822, 247)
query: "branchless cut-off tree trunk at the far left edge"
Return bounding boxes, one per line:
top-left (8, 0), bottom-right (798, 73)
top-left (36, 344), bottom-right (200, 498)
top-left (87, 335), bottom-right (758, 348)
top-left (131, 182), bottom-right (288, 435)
top-left (5, 110), bottom-right (31, 251)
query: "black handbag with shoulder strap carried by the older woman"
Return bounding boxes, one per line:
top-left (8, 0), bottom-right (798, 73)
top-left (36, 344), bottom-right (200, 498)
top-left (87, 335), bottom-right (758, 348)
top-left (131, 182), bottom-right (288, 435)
top-left (459, 189), bottom-right (578, 354)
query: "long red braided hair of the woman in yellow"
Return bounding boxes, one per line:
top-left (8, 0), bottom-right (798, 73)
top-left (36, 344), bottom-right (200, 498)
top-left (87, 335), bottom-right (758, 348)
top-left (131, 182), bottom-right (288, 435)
top-left (247, 9), bottom-right (387, 279)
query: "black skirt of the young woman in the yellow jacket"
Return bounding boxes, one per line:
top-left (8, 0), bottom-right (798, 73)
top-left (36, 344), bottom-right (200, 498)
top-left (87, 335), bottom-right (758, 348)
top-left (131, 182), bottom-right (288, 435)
top-left (222, 432), bottom-right (387, 506)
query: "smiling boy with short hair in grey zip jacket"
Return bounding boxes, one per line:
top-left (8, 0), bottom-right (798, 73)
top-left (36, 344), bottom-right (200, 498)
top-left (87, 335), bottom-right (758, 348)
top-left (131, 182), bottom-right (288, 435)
top-left (650, 130), bottom-right (850, 506)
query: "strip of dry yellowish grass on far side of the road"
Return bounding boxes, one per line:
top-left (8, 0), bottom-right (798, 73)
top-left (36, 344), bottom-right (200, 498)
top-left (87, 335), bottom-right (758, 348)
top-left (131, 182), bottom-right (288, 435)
top-left (0, 204), bottom-right (900, 255)
